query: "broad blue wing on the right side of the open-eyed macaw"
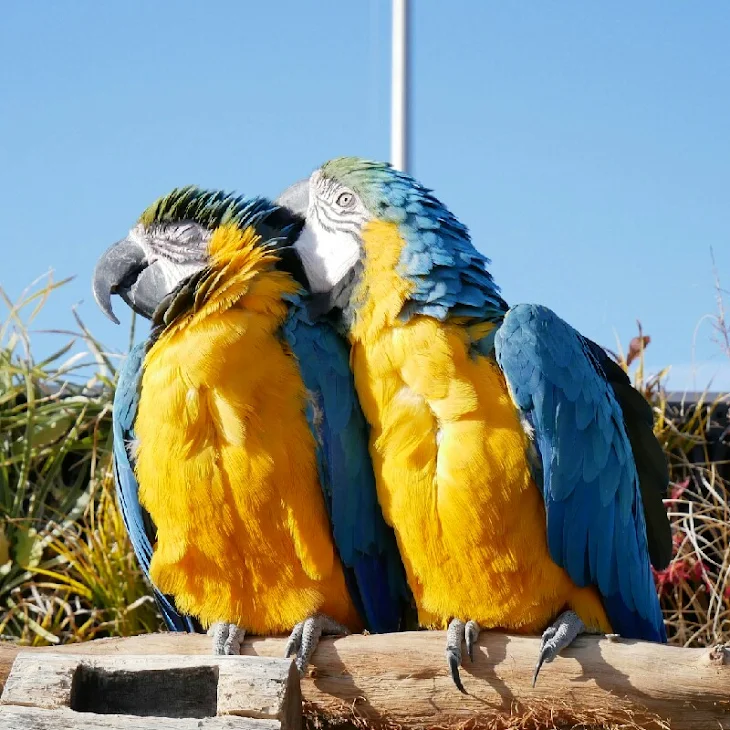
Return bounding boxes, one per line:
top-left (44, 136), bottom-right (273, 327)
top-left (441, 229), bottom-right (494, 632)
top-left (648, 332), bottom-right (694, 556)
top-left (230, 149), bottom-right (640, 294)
top-left (494, 305), bottom-right (665, 641)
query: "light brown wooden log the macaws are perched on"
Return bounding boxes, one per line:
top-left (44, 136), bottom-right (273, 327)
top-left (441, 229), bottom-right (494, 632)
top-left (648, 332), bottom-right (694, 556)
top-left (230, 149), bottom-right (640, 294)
top-left (0, 631), bottom-right (730, 730)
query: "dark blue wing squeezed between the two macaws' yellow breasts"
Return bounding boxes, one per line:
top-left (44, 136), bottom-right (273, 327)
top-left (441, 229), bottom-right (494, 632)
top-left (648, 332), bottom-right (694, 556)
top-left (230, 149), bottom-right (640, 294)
top-left (284, 305), bottom-right (410, 633)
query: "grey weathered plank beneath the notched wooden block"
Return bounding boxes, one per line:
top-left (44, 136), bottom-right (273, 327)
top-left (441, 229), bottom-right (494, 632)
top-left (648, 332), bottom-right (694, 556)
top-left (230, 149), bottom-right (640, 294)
top-left (0, 706), bottom-right (279, 730)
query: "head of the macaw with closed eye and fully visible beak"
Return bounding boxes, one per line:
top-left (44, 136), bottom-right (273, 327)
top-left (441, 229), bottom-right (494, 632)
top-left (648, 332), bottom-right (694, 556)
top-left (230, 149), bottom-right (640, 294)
top-left (93, 186), bottom-right (306, 324)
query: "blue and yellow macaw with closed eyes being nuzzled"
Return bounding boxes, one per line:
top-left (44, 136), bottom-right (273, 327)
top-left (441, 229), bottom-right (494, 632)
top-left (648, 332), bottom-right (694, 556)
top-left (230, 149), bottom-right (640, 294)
top-left (94, 187), bottom-right (408, 671)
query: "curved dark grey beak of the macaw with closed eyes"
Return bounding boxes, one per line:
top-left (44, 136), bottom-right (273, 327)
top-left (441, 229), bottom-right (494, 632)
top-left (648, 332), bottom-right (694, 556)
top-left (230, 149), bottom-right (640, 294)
top-left (93, 238), bottom-right (167, 324)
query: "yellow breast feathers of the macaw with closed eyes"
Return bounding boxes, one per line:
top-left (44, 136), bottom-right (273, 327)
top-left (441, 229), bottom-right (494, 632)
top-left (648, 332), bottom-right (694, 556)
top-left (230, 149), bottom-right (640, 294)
top-left (136, 226), bottom-right (359, 633)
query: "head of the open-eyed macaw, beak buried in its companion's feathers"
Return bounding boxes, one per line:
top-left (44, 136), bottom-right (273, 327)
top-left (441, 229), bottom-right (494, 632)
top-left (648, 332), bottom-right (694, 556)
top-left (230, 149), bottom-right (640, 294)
top-left (282, 157), bottom-right (506, 326)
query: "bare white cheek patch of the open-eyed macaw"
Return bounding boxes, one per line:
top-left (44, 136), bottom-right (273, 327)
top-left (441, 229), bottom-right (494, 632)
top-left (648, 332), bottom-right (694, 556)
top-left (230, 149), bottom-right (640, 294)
top-left (294, 215), bottom-right (360, 293)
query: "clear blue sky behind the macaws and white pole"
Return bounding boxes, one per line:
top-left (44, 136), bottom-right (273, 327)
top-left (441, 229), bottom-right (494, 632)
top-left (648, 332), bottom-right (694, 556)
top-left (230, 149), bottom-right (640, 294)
top-left (0, 0), bottom-right (730, 389)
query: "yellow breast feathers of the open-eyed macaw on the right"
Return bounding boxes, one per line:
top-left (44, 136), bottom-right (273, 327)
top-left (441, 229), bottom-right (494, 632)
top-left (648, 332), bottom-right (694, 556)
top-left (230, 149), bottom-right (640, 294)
top-left (352, 223), bottom-right (608, 631)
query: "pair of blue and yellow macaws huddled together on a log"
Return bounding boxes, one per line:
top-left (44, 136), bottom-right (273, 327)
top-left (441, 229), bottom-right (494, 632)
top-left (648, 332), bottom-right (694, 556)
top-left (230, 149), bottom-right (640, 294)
top-left (95, 158), bottom-right (671, 691)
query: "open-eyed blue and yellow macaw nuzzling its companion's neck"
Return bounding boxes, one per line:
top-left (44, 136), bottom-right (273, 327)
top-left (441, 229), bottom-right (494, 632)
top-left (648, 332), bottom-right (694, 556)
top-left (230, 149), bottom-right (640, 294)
top-left (280, 158), bottom-right (671, 691)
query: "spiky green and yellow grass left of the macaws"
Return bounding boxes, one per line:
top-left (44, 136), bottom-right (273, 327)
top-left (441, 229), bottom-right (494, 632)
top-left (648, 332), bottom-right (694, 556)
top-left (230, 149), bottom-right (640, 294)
top-left (0, 279), bottom-right (160, 645)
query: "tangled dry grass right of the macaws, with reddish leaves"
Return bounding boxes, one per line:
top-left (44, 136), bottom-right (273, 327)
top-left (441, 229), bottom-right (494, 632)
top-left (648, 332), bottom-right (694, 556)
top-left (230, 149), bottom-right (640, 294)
top-left (617, 280), bottom-right (730, 647)
